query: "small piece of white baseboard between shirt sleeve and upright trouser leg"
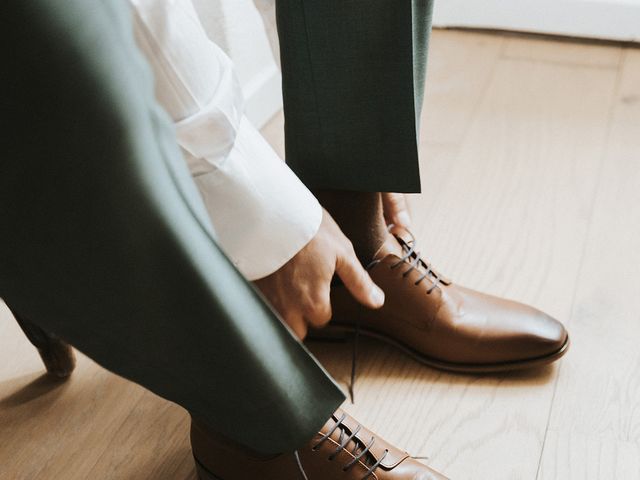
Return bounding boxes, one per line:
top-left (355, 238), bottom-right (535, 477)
top-left (242, 64), bottom-right (282, 129)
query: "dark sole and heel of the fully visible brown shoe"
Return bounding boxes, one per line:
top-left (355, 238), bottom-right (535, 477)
top-left (309, 324), bottom-right (570, 374)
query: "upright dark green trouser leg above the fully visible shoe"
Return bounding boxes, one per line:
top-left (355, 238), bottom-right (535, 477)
top-left (276, 0), bottom-right (433, 192)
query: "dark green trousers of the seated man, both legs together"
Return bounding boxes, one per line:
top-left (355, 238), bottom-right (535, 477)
top-left (0, 0), bottom-right (436, 453)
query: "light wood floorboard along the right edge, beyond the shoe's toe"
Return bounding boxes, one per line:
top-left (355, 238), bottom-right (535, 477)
top-left (539, 50), bottom-right (640, 480)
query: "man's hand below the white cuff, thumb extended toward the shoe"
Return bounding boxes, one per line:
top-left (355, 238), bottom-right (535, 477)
top-left (254, 211), bottom-right (384, 339)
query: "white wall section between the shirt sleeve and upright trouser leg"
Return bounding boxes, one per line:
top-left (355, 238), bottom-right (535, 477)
top-left (193, 0), bottom-right (282, 128)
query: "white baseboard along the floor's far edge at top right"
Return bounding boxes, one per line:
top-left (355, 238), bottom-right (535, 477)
top-left (434, 0), bottom-right (640, 42)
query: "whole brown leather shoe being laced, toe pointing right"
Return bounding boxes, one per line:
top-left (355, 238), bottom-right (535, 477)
top-left (322, 234), bottom-right (569, 373)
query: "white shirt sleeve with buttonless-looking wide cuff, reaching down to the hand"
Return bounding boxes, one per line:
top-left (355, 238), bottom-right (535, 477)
top-left (129, 0), bottom-right (322, 280)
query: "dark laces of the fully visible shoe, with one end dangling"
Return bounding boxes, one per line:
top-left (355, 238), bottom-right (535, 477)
top-left (349, 224), bottom-right (446, 403)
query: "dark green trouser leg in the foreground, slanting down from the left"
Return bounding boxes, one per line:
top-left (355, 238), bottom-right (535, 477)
top-left (0, 0), bottom-right (344, 453)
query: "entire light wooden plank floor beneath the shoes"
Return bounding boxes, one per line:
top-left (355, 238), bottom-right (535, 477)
top-left (0, 31), bottom-right (640, 480)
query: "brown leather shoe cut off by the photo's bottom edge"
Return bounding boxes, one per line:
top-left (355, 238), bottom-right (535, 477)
top-left (191, 410), bottom-right (447, 480)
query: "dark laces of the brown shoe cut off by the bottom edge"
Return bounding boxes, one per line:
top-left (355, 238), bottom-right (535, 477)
top-left (294, 413), bottom-right (389, 480)
